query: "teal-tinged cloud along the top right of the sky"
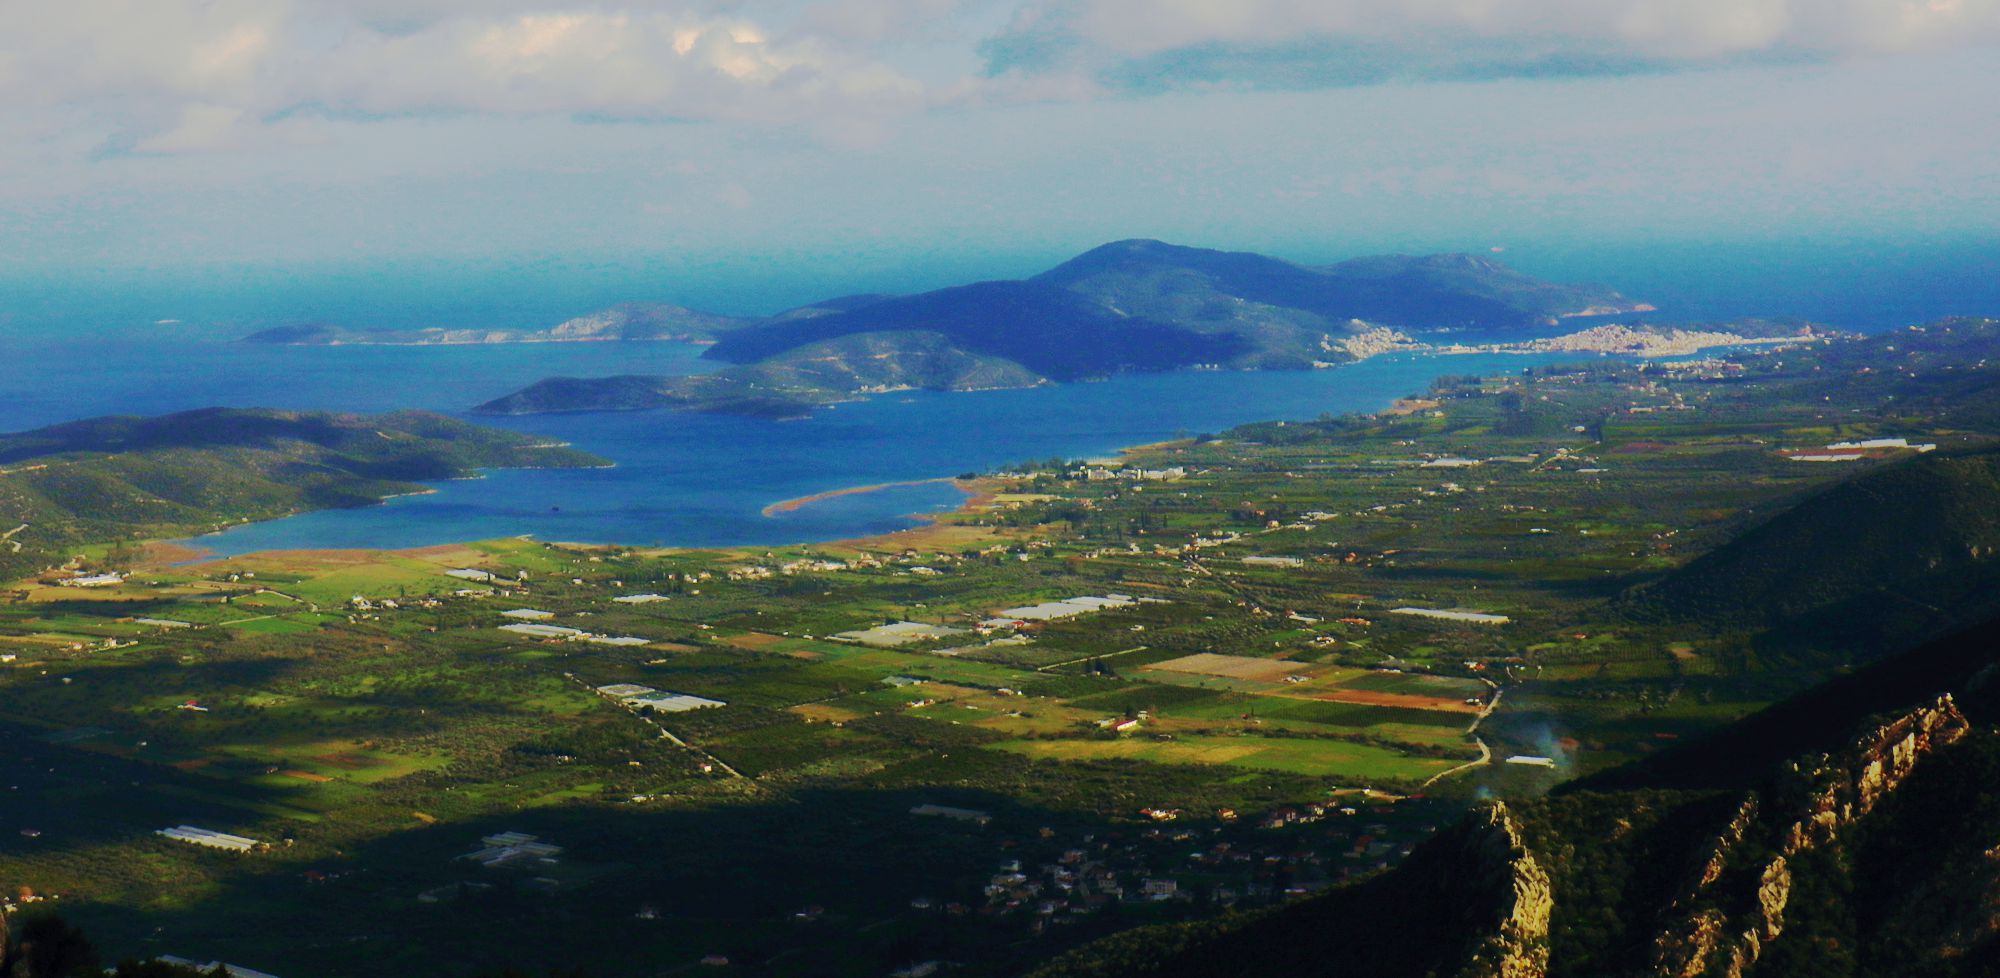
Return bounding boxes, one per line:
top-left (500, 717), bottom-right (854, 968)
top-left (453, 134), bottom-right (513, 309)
top-left (980, 0), bottom-right (2000, 92)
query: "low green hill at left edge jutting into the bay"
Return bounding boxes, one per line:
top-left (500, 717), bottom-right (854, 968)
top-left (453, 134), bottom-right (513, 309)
top-left (0, 408), bottom-right (606, 576)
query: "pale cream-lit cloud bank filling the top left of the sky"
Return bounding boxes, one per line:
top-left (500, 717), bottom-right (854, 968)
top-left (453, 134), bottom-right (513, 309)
top-left (0, 0), bottom-right (924, 152)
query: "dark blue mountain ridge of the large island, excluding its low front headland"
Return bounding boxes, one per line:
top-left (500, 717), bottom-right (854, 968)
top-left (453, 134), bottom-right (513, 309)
top-left (708, 240), bottom-right (1634, 370)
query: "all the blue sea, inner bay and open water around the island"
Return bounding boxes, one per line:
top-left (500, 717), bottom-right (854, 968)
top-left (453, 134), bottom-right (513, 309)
top-left (0, 236), bottom-right (2000, 554)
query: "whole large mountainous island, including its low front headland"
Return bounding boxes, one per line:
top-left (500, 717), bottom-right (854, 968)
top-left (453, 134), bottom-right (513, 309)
top-left (474, 240), bottom-right (1654, 418)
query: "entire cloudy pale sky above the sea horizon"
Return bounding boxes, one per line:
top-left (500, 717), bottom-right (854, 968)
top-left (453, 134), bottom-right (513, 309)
top-left (0, 0), bottom-right (2000, 310)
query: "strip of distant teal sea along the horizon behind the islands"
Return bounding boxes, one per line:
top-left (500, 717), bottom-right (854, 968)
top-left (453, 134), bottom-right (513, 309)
top-left (0, 234), bottom-right (2000, 338)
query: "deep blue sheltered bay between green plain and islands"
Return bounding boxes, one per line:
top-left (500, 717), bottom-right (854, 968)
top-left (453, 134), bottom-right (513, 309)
top-left (0, 338), bottom-right (1560, 554)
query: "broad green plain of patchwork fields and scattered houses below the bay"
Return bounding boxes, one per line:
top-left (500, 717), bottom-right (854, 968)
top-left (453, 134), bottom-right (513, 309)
top-left (0, 322), bottom-right (1988, 978)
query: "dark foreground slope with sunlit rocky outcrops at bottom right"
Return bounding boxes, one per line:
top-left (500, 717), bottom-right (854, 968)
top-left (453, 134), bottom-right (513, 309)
top-left (1040, 680), bottom-right (2000, 978)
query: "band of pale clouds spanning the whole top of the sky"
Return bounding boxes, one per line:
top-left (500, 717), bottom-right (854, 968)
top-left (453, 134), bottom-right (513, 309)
top-left (0, 0), bottom-right (2000, 156)
